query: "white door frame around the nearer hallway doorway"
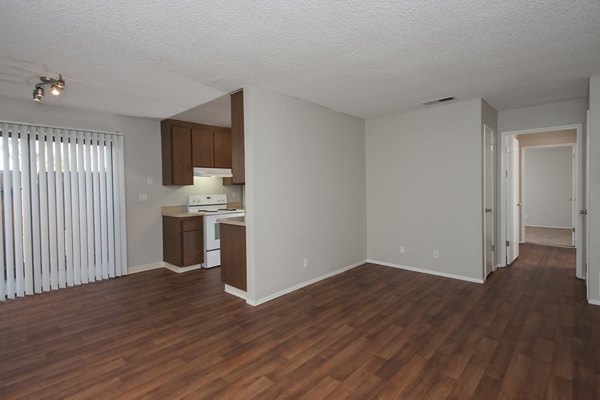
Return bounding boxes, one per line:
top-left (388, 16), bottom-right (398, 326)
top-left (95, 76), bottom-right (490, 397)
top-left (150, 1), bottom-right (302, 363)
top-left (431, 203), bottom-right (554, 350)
top-left (496, 124), bottom-right (585, 279)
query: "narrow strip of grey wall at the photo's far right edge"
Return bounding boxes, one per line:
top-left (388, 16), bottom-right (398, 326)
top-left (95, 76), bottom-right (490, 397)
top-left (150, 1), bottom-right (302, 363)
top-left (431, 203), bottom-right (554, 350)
top-left (588, 75), bottom-right (600, 304)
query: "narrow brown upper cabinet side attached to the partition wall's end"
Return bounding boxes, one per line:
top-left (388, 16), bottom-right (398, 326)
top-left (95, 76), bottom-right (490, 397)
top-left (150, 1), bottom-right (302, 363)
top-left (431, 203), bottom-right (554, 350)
top-left (231, 90), bottom-right (246, 185)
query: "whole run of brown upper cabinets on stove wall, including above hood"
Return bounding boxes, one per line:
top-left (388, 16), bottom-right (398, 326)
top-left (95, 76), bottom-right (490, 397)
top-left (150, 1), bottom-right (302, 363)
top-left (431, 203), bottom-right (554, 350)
top-left (161, 119), bottom-right (232, 185)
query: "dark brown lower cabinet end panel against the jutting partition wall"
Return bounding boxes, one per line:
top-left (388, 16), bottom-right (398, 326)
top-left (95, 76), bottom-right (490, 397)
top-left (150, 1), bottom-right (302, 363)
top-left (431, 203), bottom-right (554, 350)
top-left (219, 224), bottom-right (246, 291)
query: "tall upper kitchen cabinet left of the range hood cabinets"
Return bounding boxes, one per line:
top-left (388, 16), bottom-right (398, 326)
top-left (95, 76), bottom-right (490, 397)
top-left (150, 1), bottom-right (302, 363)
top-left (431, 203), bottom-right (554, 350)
top-left (160, 119), bottom-right (194, 185)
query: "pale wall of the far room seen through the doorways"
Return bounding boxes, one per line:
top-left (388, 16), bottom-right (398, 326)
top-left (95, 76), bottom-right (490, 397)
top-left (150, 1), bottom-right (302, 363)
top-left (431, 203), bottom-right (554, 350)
top-left (522, 146), bottom-right (573, 228)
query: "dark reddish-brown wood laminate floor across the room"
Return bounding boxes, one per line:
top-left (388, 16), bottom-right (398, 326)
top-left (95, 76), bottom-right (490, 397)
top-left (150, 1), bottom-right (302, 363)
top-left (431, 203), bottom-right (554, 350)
top-left (0, 245), bottom-right (600, 399)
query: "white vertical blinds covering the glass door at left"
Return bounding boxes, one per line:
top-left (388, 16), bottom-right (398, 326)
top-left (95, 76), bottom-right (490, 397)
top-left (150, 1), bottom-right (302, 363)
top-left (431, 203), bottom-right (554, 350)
top-left (0, 122), bottom-right (127, 300)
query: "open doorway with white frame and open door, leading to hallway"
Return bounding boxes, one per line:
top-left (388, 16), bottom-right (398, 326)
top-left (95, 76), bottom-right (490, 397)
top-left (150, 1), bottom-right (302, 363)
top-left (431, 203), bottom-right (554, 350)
top-left (497, 125), bottom-right (585, 278)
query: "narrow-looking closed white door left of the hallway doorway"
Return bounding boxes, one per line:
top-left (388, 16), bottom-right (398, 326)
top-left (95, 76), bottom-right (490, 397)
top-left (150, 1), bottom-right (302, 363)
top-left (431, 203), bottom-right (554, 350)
top-left (483, 125), bottom-right (496, 277)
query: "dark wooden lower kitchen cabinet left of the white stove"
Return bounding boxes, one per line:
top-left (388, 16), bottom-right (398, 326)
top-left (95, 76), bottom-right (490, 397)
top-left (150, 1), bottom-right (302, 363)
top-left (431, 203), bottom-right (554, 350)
top-left (163, 215), bottom-right (204, 267)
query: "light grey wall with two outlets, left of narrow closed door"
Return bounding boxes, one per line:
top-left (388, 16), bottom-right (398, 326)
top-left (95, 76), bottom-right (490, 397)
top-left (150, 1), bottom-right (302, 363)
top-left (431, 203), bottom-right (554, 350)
top-left (366, 99), bottom-right (483, 280)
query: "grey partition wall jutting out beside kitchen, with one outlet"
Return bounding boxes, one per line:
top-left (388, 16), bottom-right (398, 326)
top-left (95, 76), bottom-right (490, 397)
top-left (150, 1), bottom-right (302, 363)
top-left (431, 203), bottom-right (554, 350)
top-left (244, 87), bottom-right (366, 302)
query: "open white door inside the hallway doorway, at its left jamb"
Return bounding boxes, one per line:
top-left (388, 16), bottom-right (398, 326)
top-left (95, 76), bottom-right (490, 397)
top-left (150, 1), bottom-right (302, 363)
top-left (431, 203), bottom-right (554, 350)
top-left (505, 136), bottom-right (521, 265)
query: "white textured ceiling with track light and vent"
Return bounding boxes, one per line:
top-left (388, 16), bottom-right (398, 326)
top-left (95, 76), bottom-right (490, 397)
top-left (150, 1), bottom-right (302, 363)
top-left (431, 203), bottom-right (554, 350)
top-left (0, 0), bottom-right (600, 118)
